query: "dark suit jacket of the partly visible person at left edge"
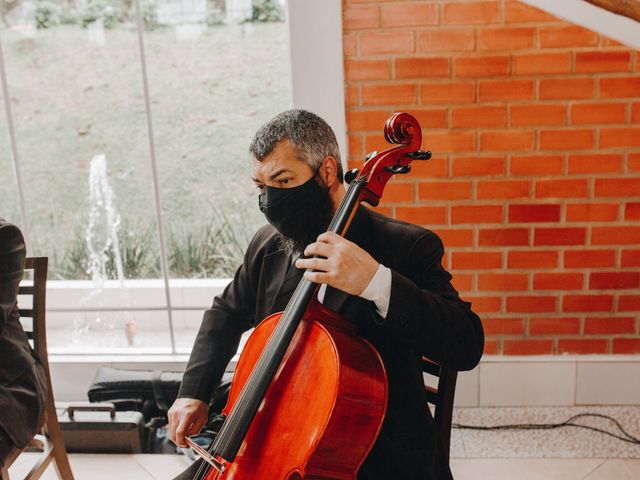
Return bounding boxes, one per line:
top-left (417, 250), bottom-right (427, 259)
top-left (0, 219), bottom-right (47, 448)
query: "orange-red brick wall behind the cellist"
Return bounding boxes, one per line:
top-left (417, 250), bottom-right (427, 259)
top-left (343, 0), bottom-right (640, 355)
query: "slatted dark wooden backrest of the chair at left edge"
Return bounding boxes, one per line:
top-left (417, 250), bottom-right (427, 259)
top-left (18, 257), bottom-right (49, 368)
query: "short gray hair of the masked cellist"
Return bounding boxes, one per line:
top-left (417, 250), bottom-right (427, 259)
top-left (249, 110), bottom-right (342, 181)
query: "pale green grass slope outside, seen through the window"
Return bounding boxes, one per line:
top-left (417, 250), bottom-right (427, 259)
top-left (0, 23), bottom-right (290, 278)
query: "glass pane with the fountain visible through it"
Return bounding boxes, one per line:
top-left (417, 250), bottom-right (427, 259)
top-left (1, 0), bottom-right (170, 352)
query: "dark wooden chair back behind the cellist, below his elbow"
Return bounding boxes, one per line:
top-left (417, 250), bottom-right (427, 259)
top-left (422, 357), bottom-right (458, 462)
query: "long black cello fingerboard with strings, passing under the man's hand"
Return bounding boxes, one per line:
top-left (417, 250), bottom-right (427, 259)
top-left (212, 180), bottom-right (364, 458)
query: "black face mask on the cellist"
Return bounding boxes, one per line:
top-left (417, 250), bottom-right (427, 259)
top-left (258, 171), bottom-right (333, 251)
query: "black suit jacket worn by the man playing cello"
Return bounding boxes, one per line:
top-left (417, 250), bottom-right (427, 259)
top-left (179, 207), bottom-right (484, 480)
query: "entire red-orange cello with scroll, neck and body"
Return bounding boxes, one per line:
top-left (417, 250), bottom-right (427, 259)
top-left (186, 113), bottom-right (431, 480)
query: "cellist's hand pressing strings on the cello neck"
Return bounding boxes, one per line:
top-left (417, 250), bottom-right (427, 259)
top-left (296, 232), bottom-right (379, 295)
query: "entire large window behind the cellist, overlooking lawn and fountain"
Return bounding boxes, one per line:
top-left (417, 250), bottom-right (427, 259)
top-left (0, 0), bottom-right (291, 353)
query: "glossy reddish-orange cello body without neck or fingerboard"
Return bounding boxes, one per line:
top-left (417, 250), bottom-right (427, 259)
top-left (205, 300), bottom-right (387, 480)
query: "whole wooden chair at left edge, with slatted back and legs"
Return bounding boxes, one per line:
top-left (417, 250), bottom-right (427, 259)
top-left (2, 257), bottom-right (73, 480)
